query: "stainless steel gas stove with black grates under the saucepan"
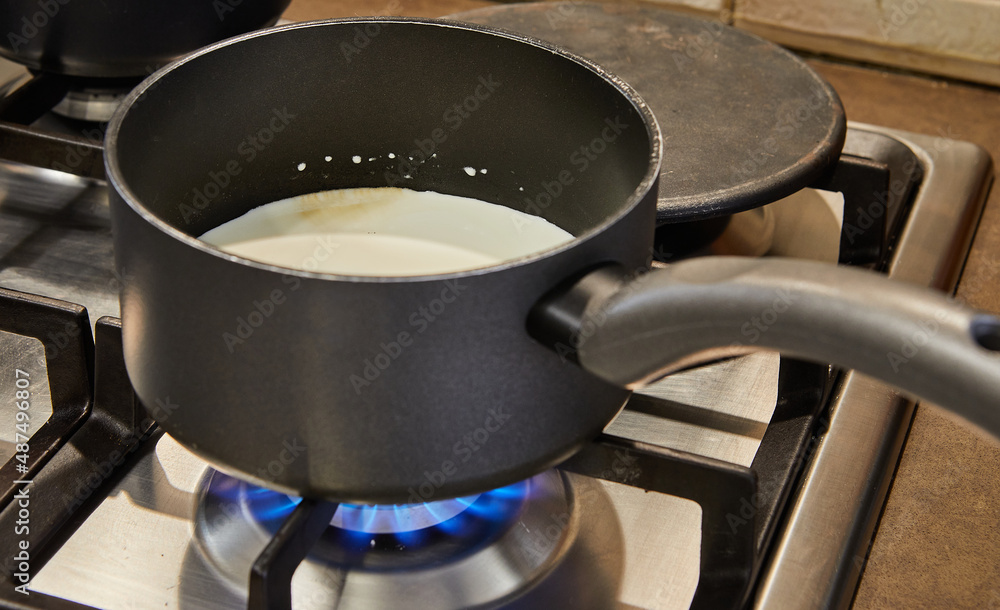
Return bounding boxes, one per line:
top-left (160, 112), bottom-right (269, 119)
top-left (0, 5), bottom-right (991, 609)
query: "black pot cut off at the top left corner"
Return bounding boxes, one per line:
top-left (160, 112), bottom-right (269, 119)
top-left (0, 0), bottom-right (290, 78)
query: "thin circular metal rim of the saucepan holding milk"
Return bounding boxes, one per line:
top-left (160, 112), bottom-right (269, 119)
top-left (104, 17), bottom-right (662, 283)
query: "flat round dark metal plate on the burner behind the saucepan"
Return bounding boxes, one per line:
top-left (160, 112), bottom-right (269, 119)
top-left (453, 2), bottom-right (847, 223)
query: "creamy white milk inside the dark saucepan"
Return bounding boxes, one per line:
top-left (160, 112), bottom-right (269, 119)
top-left (200, 187), bottom-right (573, 276)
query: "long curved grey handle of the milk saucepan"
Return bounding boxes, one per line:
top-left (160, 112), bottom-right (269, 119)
top-left (528, 257), bottom-right (1000, 438)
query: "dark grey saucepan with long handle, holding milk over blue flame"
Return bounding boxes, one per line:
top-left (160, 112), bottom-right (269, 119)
top-left (105, 19), bottom-right (1000, 502)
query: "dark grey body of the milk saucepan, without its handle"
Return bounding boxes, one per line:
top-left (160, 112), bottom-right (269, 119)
top-left (106, 20), bottom-right (659, 501)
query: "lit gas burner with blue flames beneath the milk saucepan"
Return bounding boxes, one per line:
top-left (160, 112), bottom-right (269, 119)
top-left (195, 471), bottom-right (578, 608)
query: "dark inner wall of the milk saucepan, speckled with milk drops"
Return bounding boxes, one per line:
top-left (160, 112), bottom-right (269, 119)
top-left (111, 20), bottom-right (654, 245)
